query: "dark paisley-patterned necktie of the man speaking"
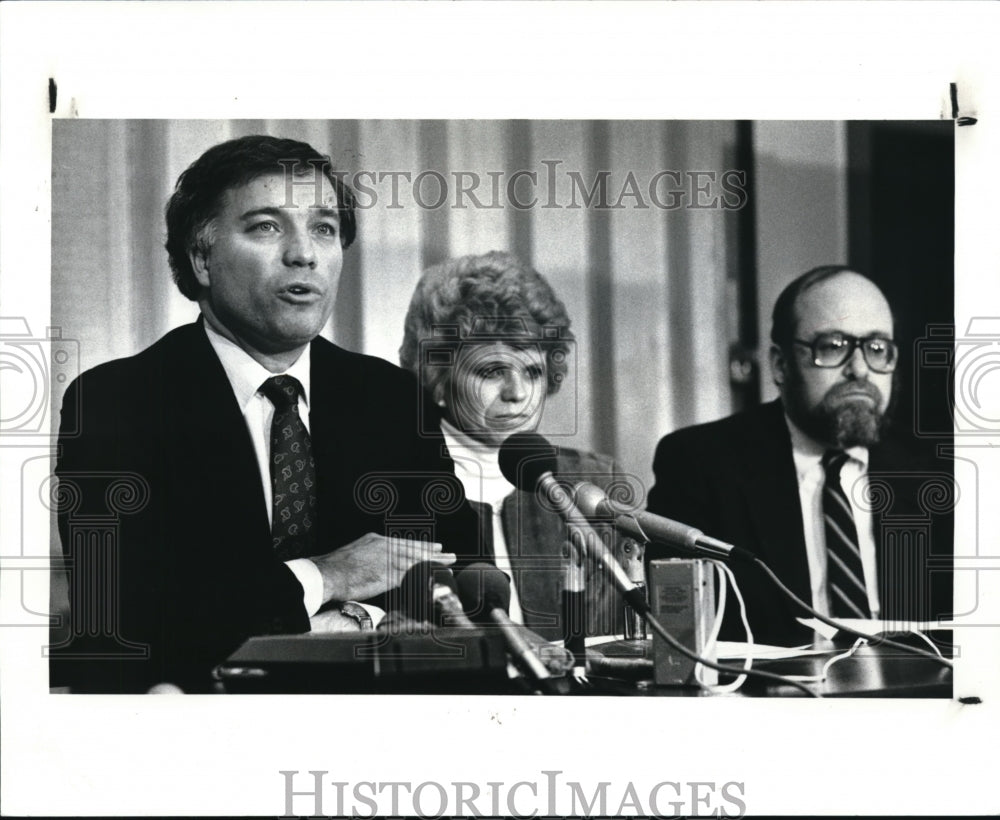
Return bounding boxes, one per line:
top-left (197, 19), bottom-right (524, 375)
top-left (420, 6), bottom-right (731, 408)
top-left (260, 376), bottom-right (316, 561)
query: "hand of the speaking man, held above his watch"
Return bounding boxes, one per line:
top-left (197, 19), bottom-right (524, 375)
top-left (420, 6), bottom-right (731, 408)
top-left (309, 532), bottom-right (456, 603)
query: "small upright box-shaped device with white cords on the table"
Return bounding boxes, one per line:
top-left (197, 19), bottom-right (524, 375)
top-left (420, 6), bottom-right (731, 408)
top-left (649, 558), bottom-right (718, 686)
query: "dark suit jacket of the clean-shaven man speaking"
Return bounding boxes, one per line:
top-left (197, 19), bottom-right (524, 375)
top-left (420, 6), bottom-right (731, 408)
top-left (51, 321), bottom-right (477, 692)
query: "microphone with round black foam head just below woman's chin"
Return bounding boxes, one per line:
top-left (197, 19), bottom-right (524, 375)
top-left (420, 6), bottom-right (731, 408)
top-left (499, 433), bottom-right (649, 613)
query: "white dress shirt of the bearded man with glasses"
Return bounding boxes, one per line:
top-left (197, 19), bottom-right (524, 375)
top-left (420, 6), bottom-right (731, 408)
top-left (785, 415), bottom-right (880, 618)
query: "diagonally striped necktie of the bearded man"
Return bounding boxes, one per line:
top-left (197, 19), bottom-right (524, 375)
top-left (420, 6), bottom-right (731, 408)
top-left (823, 450), bottom-right (871, 618)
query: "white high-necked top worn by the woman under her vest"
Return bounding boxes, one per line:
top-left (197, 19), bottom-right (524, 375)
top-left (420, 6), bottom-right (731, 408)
top-left (441, 419), bottom-right (524, 624)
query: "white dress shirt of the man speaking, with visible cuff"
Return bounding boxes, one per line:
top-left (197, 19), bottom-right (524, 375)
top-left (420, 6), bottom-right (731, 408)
top-left (204, 320), bottom-right (324, 620)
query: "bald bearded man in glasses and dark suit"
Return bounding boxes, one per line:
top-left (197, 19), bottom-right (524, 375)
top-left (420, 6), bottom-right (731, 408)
top-left (648, 265), bottom-right (953, 645)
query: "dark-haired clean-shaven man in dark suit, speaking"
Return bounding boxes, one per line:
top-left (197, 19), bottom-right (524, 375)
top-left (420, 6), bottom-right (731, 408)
top-left (52, 136), bottom-right (476, 692)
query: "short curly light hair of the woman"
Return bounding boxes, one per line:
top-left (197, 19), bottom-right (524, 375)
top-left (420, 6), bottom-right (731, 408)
top-left (399, 251), bottom-right (573, 395)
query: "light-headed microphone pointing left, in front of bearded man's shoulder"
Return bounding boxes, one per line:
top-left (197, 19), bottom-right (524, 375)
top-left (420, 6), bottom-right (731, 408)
top-left (573, 481), bottom-right (755, 562)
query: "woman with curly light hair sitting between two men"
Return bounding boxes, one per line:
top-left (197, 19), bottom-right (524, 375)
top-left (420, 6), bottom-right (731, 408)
top-left (400, 251), bottom-right (622, 640)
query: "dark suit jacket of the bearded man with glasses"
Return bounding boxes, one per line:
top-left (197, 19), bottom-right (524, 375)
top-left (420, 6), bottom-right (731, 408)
top-left (647, 401), bottom-right (954, 646)
